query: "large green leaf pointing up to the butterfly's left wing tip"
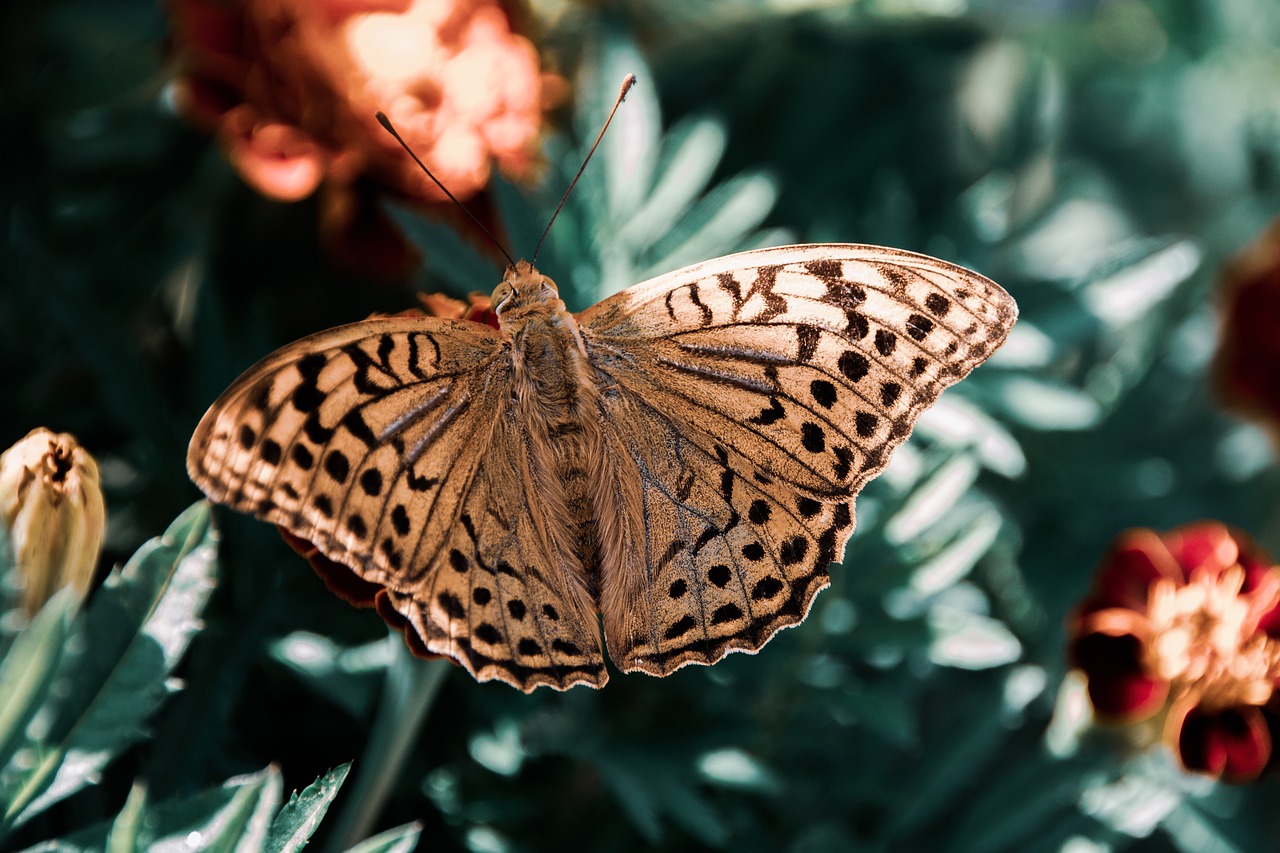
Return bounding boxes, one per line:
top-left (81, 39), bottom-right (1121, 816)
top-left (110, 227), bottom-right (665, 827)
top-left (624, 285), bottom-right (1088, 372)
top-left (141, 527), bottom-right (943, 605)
top-left (0, 502), bottom-right (216, 825)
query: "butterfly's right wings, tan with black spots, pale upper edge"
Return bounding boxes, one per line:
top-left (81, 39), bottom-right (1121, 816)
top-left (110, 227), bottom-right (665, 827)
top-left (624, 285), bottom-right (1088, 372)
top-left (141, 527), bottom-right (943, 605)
top-left (580, 239), bottom-right (1016, 675)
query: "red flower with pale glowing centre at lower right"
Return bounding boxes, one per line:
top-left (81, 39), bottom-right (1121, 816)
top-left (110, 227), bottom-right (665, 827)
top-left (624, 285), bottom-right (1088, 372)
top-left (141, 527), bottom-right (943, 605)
top-left (1071, 521), bottom-right (1280, 781)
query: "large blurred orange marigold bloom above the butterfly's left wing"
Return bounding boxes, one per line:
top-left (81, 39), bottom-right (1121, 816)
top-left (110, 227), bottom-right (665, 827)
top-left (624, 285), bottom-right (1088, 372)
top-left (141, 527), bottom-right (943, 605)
top-left (170, 0), bottom-right (544, 201)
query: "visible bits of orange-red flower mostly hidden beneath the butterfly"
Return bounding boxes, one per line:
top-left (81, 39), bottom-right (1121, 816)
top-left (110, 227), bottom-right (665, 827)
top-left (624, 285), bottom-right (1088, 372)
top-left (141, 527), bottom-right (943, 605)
top-left (276, 285), bottom-right (498, 663)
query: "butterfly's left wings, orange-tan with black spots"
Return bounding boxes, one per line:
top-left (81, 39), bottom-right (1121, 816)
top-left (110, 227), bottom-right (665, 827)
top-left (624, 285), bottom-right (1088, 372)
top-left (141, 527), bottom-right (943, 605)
top-left (187, 318), bottom-right (607, 690)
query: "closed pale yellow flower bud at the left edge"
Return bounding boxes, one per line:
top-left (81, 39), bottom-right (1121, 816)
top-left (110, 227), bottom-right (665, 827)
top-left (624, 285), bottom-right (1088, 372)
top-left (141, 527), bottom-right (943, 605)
top-left (0, 427), bottom-right (106, 616)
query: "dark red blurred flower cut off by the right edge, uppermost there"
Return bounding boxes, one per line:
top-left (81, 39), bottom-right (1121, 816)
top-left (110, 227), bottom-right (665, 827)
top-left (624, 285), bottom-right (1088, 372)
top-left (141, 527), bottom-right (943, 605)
top-left (1215, 219), bottom-right (1280, 434)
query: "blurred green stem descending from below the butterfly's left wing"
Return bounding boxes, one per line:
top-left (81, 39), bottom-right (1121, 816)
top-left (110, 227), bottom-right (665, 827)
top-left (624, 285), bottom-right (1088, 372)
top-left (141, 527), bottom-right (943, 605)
top-left (324, 631), bottom-right (453, 853)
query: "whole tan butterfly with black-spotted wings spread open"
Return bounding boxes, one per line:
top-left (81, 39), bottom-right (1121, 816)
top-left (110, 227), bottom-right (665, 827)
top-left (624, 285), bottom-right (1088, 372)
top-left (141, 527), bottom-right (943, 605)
top-left (187, 243), bottom-right (1018, 692)
